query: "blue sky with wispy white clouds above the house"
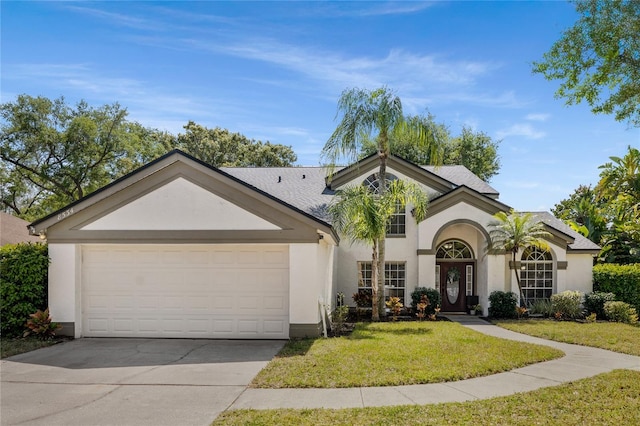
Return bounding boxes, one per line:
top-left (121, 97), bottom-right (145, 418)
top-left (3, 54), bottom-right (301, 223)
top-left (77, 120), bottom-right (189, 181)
top-left (0, 1), bottom-right (640, 210)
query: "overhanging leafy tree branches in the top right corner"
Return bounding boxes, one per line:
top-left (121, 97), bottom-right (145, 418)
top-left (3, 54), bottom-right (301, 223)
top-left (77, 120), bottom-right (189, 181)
top-left (533, 0), bottom-right (640, 126)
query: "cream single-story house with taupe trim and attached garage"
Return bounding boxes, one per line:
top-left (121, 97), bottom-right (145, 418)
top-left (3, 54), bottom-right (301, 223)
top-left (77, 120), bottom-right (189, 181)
top-left (30, 151), bottom-right (598, 339)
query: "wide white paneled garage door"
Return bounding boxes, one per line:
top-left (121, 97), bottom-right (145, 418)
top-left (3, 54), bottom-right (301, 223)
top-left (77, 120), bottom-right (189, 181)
top-left (82, 245), bottom-right (289, 339)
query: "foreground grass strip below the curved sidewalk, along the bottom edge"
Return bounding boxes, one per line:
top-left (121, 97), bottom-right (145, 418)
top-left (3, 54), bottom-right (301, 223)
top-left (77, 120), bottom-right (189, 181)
top-left (213, 370), bottom-right (640, 426)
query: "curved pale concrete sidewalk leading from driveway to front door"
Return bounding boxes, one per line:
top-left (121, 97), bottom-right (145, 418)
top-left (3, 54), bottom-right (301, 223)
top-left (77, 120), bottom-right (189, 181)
top-left (227, 315), bottom-right (640, 410)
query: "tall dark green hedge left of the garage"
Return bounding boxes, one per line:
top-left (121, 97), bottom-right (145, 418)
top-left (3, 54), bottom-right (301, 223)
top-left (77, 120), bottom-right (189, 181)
top-left (0, 243), bottom-right (49, 337)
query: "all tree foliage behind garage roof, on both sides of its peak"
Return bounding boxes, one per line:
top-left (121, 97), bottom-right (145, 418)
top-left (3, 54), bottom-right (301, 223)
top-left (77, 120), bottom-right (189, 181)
top-left (0, 95), bottom-right (296, 220)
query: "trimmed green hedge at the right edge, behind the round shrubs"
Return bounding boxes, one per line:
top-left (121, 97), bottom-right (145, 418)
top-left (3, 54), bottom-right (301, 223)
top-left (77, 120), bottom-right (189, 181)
top-left (593, 263), bottom-right (640, 312)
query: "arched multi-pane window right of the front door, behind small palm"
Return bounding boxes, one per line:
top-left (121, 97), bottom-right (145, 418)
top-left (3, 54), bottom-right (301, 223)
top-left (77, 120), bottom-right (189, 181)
top-left (520, 247), bottom-right (553, 304)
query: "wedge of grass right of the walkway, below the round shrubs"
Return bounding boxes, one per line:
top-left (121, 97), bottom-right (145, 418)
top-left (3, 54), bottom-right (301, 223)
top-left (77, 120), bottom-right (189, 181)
top-left (494, 320), bottom-right (640, 356)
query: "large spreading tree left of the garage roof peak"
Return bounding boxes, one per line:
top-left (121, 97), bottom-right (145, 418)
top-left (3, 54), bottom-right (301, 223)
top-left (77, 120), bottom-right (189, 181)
top-left (0, 95), bottom-right (168, 219)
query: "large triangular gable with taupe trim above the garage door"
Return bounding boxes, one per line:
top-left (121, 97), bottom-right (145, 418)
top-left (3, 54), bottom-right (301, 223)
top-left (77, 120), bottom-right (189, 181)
top-left (31, 151), bottom-right (337, 243)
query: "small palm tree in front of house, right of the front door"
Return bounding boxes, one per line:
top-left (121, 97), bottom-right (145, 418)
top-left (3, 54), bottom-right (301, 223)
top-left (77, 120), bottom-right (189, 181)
top-left (487, 210), bottom-right (551, 306)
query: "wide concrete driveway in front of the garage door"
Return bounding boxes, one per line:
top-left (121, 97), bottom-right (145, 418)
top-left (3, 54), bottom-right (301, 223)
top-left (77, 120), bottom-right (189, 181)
top-left (0, 339), bottom-right (284, 426)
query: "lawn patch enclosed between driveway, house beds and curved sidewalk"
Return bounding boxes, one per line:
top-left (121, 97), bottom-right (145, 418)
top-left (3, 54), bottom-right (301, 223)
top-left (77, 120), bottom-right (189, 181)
top-left (252, 321), bottom-right (564, 388)
